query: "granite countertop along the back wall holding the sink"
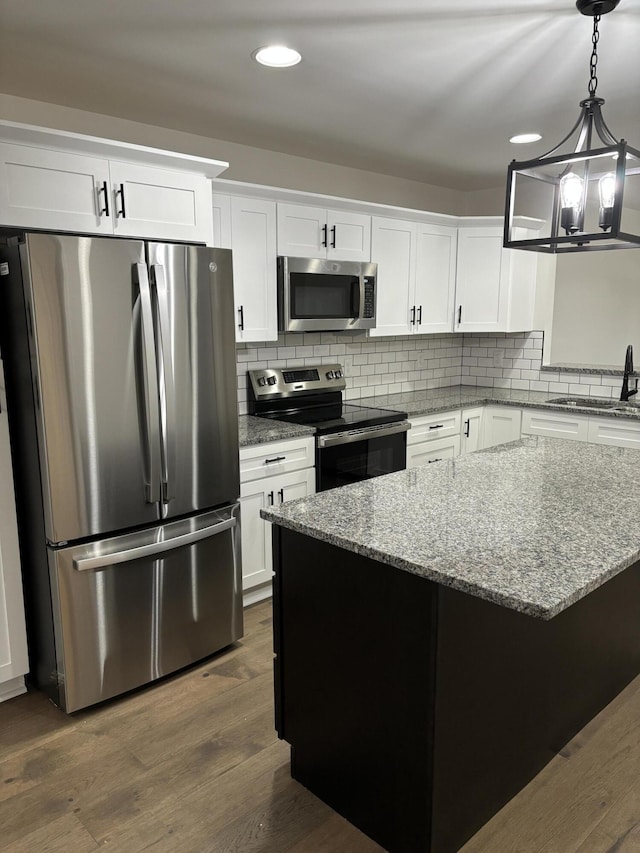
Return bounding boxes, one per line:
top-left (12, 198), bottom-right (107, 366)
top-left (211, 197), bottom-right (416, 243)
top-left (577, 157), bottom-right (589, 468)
top-left (356, 385), bottom-right (640, 420)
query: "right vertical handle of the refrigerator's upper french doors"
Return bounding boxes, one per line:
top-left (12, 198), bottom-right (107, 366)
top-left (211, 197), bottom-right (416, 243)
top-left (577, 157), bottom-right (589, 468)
top-left (151, 264), bottom-right (178, 503)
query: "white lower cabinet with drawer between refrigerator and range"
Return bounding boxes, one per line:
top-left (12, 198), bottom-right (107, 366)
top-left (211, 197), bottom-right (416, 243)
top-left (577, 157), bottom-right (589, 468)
top-left (240, 438), bottom-right (315, 595)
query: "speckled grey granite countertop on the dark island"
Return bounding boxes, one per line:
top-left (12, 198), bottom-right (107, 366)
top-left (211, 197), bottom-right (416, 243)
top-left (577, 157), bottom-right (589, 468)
top-left (261, 436), bottom-right (640, 619)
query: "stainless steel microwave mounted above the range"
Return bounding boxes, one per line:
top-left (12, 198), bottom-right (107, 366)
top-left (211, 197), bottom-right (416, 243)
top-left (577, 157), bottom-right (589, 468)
top-left (278, 257), bottom-right (378, 332)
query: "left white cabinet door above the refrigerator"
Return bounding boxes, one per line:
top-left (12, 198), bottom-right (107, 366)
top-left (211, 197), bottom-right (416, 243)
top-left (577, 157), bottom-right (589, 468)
top-left (0, 143), bottom-right (114, 234)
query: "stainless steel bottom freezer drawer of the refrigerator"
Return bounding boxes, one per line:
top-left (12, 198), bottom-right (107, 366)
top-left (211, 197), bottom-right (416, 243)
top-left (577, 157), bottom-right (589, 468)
top-left (49, 504), bottom-right (242, 712)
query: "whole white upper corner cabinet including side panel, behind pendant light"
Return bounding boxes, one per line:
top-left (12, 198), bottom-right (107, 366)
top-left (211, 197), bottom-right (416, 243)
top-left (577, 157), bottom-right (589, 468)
top-left (453, 227), bottom-right (537, 332)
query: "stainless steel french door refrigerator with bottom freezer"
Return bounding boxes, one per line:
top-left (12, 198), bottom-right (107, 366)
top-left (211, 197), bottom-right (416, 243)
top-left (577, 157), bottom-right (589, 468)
top-left (0, 233), bottom-right (242, 712)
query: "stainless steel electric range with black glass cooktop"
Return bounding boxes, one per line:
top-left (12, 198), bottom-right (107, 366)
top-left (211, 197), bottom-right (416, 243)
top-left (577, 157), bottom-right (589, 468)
top-left (247, 364), bottom-right (411, 491)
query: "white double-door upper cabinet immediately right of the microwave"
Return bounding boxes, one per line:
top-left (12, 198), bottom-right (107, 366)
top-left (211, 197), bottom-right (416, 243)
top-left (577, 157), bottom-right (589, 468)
top-left (371, 216), bottom-right (457, 337)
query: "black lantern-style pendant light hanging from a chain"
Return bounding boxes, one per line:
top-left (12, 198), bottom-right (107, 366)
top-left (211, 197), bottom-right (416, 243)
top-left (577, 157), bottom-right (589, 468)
top-left (504, 0), bottom-right (640, 253)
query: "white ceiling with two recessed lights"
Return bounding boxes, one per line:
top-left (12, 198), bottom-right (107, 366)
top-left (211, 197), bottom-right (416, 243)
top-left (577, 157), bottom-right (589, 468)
top-left (0, 0), bottom-right (640, 189)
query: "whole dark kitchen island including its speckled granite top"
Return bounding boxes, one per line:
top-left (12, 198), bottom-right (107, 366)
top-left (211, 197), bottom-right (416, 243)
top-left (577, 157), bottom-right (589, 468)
top-left (263, 437), bottom-right (640, 853)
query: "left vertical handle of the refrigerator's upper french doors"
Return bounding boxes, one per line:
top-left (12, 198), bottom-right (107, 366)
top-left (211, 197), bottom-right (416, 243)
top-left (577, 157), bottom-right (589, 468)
top-left (135, 264), bottom-right (161, 503)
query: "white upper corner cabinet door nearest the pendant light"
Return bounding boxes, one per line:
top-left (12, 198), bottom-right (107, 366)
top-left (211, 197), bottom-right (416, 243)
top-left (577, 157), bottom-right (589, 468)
top-left (454, 228), bottom-right (507, 332)
